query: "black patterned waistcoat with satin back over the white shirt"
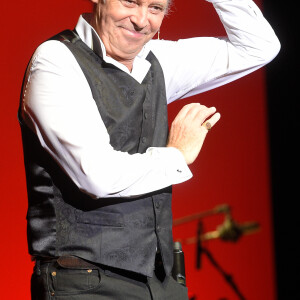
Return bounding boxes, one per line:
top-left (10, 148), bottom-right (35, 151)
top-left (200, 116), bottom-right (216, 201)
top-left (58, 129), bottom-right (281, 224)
top-left (19, 31), bottom-right (173, 276)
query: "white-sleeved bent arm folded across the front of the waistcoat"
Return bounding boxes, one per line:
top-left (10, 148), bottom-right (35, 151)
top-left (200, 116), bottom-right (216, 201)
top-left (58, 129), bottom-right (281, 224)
top-left (21, 41), bottom-right (191, 198)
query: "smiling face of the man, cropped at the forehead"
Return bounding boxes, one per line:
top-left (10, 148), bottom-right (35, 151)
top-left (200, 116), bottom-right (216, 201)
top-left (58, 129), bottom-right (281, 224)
top-left (92, 0), bottom-right (167, 62)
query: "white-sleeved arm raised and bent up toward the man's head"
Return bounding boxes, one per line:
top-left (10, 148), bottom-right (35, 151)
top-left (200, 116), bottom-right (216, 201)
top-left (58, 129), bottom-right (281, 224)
top-left (150, 0), bottom-right (280, 103)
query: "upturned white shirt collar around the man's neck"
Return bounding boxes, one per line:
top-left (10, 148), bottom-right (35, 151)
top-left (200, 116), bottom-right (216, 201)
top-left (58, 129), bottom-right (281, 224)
top-left (75, 13), bottom-right (151, 83)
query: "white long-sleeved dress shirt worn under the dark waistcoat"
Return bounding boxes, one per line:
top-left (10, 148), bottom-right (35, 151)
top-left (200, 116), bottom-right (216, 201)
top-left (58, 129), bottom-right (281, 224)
top-left (22, 0), bottom-right (280, 198)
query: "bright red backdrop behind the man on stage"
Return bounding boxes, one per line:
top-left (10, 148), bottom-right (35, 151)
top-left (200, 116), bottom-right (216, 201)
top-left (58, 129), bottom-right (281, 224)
top-left (0, 0), bottom-right (276, 300)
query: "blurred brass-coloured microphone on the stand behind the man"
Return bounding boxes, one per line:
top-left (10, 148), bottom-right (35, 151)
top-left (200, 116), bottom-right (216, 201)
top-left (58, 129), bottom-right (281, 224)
top-left (201, 215), bottom-right (260, 242)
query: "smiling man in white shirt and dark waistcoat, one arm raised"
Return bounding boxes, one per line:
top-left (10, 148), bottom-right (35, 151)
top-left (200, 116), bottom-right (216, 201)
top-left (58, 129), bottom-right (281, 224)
top-left (19, 0), bottom-right (279, 300)
